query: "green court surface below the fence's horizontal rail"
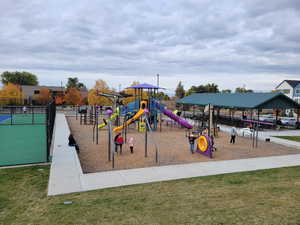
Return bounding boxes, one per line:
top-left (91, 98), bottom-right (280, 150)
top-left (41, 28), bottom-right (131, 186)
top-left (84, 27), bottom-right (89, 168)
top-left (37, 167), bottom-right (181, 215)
top-left (0, 122), bottom-right (47, 166)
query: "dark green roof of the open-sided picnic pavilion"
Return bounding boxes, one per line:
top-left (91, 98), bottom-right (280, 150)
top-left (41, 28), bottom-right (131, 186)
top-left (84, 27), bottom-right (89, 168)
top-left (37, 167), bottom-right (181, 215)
top-left (176, 93), bottom-right (300, 109)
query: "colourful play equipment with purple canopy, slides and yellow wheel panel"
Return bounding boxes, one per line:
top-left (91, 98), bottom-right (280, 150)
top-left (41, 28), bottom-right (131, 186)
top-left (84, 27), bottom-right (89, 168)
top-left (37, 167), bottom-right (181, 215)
top-left (73, 84), bottom-right (213, 171)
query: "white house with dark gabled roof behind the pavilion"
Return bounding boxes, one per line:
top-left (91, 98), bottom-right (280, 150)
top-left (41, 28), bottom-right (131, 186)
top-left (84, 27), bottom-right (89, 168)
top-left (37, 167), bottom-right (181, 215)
top-left (275, 80), bottom-right (300, 103)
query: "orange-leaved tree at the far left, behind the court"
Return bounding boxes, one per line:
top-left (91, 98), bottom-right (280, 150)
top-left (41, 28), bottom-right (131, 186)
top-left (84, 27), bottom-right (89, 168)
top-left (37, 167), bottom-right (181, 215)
top-left (0, 83), bottom-right (24, 105)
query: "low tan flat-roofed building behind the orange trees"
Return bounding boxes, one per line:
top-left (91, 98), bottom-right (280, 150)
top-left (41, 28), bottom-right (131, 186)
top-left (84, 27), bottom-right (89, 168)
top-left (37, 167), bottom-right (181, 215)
top-left (20, 85), bottom-right (65, 104)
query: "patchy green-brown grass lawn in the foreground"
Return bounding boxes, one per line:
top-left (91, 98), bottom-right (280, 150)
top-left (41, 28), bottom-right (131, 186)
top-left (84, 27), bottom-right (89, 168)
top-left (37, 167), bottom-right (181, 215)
top-left (0, 166), bottom-right (300, 225)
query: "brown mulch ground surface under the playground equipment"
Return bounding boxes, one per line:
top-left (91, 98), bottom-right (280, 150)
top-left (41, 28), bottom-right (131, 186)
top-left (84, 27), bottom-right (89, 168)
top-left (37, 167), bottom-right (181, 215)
top-left (67, 117), bottom-right (300, 173)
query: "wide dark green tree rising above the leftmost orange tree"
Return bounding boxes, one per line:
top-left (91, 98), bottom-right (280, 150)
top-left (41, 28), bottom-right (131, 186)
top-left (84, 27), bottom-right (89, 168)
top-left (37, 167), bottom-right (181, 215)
top-left (1, 71), bottom-right (38, 85)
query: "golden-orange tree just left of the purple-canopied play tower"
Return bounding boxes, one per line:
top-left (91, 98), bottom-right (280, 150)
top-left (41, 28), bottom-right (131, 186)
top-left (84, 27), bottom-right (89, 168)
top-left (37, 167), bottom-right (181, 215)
top-left (88, 79), bottom-right (112, 106)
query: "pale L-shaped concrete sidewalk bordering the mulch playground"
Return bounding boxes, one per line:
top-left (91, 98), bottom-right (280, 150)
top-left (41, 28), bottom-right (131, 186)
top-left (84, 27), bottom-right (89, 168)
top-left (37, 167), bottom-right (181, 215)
top-left (48, 114), bottom-right (300, 195)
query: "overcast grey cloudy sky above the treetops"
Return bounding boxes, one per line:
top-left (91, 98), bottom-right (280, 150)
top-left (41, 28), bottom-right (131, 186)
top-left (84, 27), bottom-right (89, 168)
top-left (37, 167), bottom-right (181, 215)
top-left (0, 0), bottom-right (300, 92)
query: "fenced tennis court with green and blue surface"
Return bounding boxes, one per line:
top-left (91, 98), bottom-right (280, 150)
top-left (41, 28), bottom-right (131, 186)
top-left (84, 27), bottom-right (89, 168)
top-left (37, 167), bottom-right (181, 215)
top-left (0, 104), bottom-right (55, 166)
